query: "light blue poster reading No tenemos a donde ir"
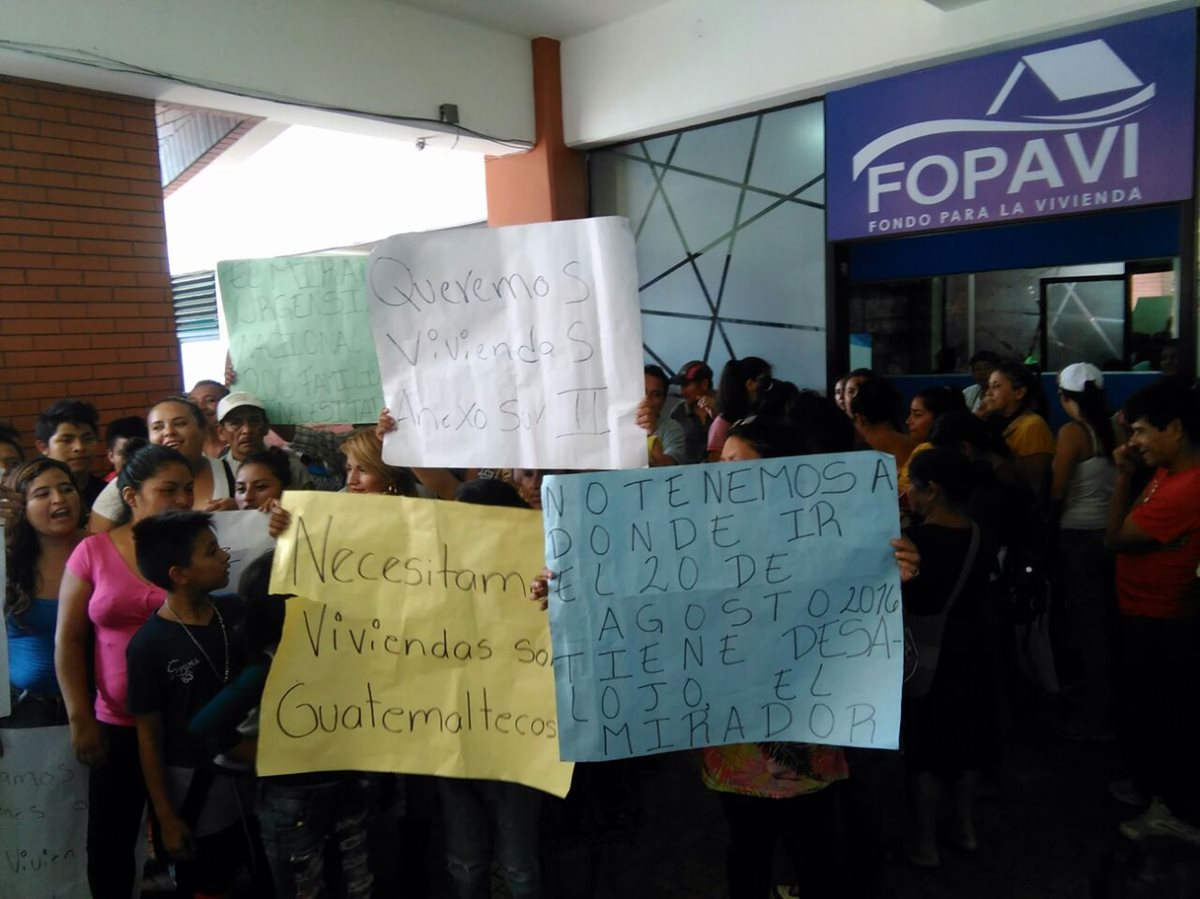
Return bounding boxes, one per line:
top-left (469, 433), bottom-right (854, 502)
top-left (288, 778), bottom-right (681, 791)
top-left (542, 451), bottom-right (904, 761)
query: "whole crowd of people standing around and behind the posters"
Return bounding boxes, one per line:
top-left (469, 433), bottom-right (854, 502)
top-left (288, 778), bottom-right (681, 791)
top-left (0, 353), bottom-right (1200, 899)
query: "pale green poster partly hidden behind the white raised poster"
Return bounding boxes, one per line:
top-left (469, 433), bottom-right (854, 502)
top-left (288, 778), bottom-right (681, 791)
top-left (217, 256), bottom-right (383, 425)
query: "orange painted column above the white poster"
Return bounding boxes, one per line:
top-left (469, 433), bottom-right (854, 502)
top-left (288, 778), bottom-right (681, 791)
top-left (485, 37), bottom-right (588, 228)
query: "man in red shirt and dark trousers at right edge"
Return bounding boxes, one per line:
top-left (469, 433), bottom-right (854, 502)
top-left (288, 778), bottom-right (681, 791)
top-left (1108, 383), bottom-right (1200, 845)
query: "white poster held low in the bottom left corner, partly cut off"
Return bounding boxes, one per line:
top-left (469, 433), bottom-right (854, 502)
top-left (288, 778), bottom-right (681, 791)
top-left (0, 726), bottom-right (90, 899)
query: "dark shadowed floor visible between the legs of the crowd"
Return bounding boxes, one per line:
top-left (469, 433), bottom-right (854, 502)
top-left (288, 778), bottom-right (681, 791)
top-left (528, 707), bottom-right (1156, 899)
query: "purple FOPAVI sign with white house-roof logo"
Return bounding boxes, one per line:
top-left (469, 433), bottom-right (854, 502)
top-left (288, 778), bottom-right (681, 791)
top-left (826, 10), bottom-right (1195, 240)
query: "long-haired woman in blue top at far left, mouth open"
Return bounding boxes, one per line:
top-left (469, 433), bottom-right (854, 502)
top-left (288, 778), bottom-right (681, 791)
top-left (0, 457), bottom-right (83, 727)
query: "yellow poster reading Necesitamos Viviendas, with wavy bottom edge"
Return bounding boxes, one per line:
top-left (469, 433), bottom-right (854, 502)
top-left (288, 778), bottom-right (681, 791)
top-left (258, 492), bottom-right (571, 796)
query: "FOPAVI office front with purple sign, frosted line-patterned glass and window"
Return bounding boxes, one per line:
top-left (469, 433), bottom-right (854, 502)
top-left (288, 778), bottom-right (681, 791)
top-left (590, 10), bottom-right (1196, 398)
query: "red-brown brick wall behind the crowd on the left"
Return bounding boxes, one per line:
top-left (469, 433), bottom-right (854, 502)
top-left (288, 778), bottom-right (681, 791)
top-left (0, 77), bottom-right (181, 456)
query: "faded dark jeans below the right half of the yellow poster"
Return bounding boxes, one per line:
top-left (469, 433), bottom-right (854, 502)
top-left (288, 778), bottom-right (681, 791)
top-left (438, 778), bottom-right (542, 899)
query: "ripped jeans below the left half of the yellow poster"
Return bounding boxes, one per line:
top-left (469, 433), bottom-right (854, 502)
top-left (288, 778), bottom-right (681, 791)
top-left (258, 774), bottom-right (374, 899)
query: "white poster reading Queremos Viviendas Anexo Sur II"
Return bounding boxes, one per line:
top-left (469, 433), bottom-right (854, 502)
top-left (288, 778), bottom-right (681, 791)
top-left (367, 217), bottom-right (647, 468)
